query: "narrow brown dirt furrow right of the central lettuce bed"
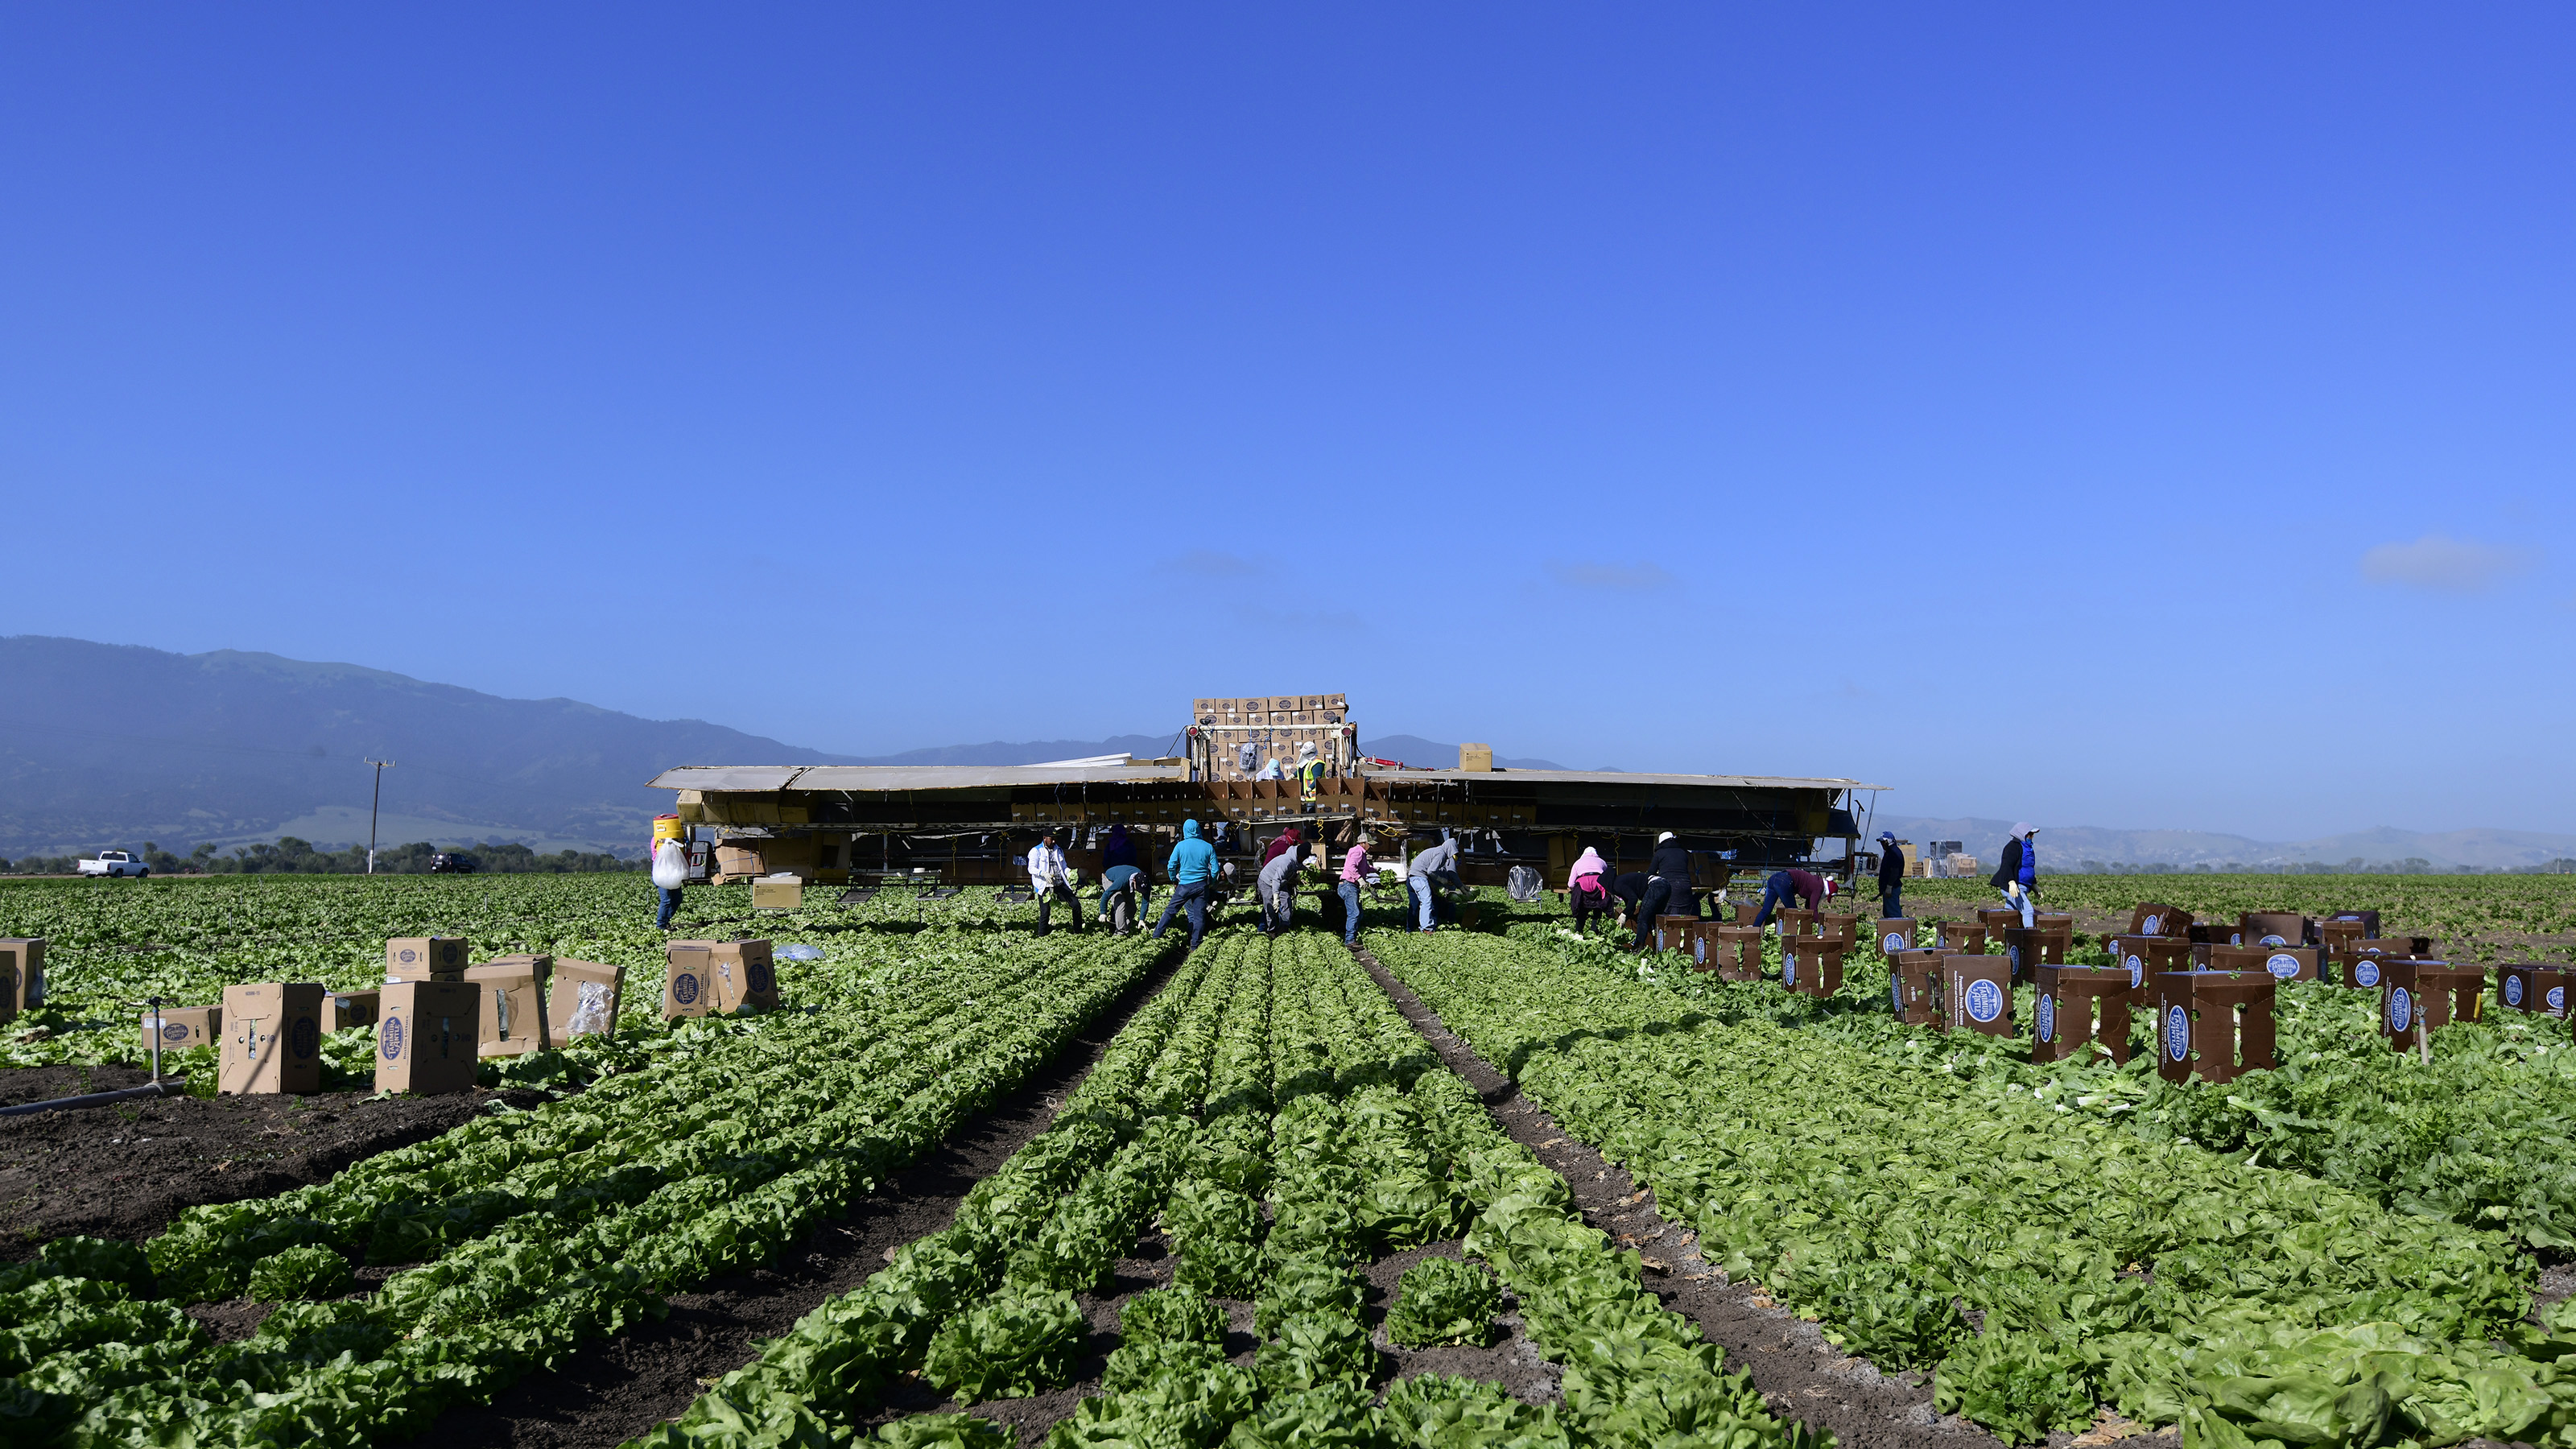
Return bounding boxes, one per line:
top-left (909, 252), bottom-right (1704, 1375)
top-left (1360, 952), bottom-right (2179, 1449)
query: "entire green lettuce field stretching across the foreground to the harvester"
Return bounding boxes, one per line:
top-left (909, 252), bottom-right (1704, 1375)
top-left (0, 877), bottom-right (2576, 1449)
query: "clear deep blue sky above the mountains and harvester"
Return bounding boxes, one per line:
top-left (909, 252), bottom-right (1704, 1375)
top-left (0, 2), bottom-right (2576, 838)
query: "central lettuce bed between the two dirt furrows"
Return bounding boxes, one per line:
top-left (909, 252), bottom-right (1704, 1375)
top-left (639, 933), bottom-right (1811, 1449)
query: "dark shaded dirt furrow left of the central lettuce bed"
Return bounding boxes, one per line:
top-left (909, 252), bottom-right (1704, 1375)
top-left (415, 948), bottom-right (1170, 1449)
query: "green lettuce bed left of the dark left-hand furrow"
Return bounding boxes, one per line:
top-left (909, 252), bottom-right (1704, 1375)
top-left (0, 931), bottom-right (1167, 1447)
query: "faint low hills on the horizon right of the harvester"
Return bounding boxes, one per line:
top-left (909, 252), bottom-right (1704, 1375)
top-left (1872, 815), bottom-right (2576, 872)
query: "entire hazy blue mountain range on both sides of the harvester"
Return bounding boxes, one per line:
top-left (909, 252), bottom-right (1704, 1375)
top-left (0, 634), bottom-right (2576, 869)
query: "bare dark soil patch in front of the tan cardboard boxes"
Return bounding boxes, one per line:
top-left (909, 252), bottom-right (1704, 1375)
top-left (0, 1067), bottom-right (543, 1261)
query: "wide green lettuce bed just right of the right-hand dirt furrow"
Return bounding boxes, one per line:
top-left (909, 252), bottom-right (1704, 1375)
top-left (1370, 933), bottom-right (2576, 1449)
